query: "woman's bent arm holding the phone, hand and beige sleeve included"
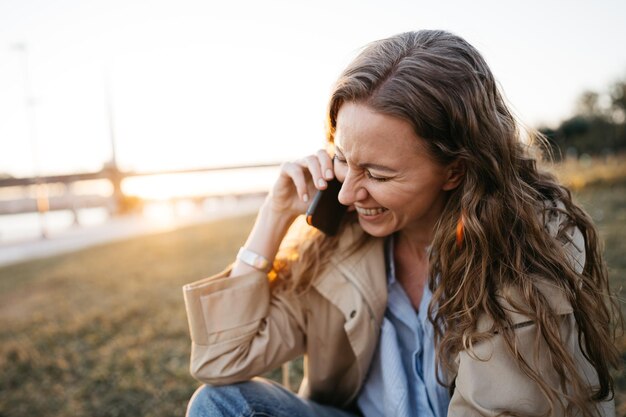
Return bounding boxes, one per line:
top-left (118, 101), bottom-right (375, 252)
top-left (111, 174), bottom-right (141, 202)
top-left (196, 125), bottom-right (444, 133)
top-left (183, 151), bottom-right (332, 384)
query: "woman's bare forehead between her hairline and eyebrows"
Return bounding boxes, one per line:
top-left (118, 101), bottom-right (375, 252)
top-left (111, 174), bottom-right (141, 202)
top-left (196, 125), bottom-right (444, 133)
top-left (334, 102), bottom-right (425, 159)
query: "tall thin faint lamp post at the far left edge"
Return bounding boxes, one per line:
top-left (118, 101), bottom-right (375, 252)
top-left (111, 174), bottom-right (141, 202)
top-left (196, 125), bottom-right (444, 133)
top-left (13, 43), bottom-right (50, 239)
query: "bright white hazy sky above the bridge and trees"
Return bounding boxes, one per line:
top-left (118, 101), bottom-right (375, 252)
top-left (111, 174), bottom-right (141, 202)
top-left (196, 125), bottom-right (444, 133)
top-left (0, 0), bottom-right (626, 177)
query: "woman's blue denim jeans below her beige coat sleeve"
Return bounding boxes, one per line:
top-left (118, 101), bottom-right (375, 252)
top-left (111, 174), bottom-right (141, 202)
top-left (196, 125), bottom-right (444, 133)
top-left (187, 378), bottom-right (359, 417)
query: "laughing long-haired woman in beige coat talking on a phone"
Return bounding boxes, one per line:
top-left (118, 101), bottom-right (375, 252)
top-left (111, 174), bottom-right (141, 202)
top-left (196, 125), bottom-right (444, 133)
top-left (184, 31), bottom-right (619, 417)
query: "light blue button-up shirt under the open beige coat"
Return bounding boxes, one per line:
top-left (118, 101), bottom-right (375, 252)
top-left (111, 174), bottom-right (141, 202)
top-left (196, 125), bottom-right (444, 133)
top-left (357, 236), bottom-right (450, 417)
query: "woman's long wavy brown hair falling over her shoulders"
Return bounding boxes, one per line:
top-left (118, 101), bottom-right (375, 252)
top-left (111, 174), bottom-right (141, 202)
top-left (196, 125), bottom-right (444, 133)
top-left (278, 30), bottom-right (623, 416)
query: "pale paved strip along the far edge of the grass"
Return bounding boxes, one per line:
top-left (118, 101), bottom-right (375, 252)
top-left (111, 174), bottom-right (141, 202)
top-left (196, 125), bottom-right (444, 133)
top-left (0, 198), bottom-right (262, 266)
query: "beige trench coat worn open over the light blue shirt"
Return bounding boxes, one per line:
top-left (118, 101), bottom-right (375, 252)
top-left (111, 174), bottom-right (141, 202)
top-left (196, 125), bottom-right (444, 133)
top-left (183, 213), bottom-right (614, 416)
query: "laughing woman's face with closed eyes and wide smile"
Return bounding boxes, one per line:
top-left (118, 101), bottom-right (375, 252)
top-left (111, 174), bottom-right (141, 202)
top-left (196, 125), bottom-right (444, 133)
top-left (334, 102), bottom-right (459, 236)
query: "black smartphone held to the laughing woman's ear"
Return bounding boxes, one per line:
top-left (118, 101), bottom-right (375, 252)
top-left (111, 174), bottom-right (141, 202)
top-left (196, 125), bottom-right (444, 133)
top-left (306, 178), bottom-right (348, 236)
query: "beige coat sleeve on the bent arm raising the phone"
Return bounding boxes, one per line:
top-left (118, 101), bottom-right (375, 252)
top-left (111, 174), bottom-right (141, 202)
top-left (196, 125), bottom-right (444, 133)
top-left (183, 271), bottom-right (305, 385)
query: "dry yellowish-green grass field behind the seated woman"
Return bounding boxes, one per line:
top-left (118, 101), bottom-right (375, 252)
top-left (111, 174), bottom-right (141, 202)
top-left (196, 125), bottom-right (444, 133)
top-left (0, 155), bottom-right (626, 417)
